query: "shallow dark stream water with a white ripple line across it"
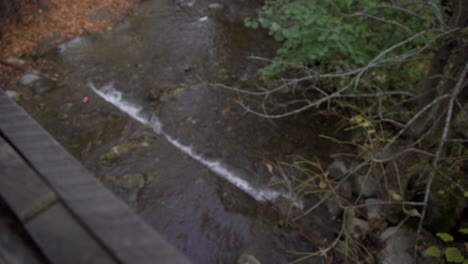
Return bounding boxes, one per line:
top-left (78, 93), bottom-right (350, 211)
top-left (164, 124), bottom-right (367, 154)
top-left (18, 0), bottom-right (346, 264)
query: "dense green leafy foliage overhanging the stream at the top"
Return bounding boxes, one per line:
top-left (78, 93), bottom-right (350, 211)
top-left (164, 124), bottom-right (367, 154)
top-left (245, 0), bottom-right (433, 89)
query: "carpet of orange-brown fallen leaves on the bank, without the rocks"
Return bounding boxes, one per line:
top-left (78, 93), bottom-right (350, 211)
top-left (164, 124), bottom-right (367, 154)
top-left (0, 0), bottom-right (138, 59)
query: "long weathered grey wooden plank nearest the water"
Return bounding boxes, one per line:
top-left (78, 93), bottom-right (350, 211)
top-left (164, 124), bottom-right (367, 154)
top-left (0, 92), bottom-right (189, 264)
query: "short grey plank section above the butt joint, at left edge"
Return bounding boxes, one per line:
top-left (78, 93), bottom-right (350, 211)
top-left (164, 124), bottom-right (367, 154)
top-left (0, 137), bottom-right (58, 222)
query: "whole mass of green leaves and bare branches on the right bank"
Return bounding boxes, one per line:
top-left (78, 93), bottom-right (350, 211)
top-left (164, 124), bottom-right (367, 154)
top-left (239, 0), bottom-right (468, 263)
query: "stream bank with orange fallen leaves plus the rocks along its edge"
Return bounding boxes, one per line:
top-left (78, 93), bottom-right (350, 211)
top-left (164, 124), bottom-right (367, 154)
top-left (0, 0), bottom-right (139, 98)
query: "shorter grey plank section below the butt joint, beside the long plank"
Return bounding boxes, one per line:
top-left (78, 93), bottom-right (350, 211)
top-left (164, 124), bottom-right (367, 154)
top-left (26, 204), bottom-right (117, 264)
